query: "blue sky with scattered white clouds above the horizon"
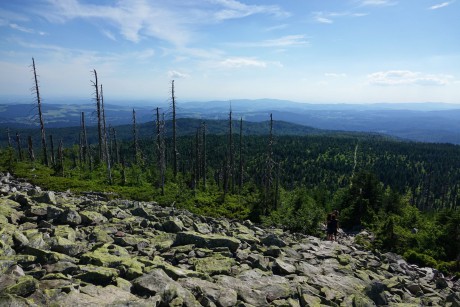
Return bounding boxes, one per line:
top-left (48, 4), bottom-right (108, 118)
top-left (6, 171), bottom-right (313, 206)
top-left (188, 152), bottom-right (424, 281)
top-left (0, 0), bottom-right (460, 103)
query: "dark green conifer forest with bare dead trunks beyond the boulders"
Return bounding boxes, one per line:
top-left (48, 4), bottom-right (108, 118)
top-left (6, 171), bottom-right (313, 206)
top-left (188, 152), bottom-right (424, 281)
top-left (0, 71), bottom-right (460, 274)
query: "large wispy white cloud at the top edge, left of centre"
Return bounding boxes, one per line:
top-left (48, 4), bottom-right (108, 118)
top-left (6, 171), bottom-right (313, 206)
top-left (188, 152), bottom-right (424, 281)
top-left (39, 0), bottom-right (289, 46)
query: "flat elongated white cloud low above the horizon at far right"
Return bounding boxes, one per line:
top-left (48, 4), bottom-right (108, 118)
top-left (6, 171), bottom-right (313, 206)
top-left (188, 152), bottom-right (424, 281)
top-left (367, 70), bottom-right (453, 86)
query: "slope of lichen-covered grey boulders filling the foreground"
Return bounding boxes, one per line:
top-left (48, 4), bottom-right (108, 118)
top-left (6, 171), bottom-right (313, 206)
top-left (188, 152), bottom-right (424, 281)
top-left (0, 174), bottom-right (460, 306)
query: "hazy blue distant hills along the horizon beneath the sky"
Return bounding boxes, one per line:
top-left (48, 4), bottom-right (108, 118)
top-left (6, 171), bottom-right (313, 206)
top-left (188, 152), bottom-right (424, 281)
top-left (0, 99), bottom-right (460, 144)
